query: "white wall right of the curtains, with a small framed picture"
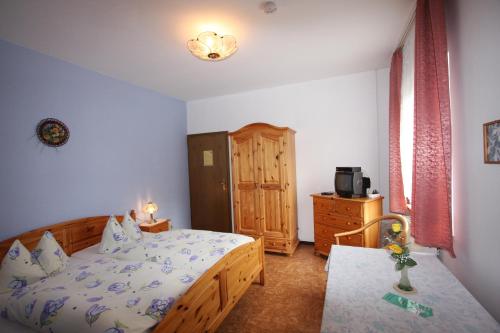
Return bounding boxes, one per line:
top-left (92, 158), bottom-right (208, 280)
top-left (443, 0), bottom-right (500, 321)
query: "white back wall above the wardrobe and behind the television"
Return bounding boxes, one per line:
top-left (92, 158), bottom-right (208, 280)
top-left (187, 71), bottom-right (379, 241)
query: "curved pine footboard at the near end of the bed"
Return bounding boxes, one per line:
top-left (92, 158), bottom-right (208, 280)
top-left (153, 238), bottom-right (264, 333)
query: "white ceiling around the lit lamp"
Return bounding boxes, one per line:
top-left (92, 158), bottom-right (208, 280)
top-left (0, 0), bottom-right (415, 100)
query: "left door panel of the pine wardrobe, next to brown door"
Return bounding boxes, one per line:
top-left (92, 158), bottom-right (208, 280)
top-left (231, 133), bottom-right (261, 235)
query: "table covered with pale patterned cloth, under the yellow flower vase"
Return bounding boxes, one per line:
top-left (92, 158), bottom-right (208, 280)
top-left (321, 245), bottom-right (500, 333)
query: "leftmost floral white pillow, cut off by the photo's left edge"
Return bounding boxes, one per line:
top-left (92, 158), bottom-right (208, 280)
top-left (0, 239), bottom-right (47, 292)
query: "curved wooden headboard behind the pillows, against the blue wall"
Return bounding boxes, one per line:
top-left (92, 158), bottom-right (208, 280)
top-left (0, 210), bottom-right (136, 261)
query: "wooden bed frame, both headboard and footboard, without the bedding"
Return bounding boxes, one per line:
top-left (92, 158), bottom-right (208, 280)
top-left (0, 211), bottom-right (264, 333)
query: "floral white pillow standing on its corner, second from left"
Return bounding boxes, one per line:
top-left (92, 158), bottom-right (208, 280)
top-left (32, 231), bottom-right (69, 275)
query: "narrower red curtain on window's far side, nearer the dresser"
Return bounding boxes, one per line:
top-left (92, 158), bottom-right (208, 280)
top-left (389, 49), bottom-right (407, 214)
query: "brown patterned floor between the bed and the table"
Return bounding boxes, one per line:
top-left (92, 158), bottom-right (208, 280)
top-left (217, 244), bottom-right (326, 333)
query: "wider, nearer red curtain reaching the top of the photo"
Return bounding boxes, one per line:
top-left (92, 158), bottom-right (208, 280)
top-left (411, 0), bottom-right (454, 256)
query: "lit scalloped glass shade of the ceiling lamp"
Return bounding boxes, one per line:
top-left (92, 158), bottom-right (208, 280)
top-left (187, 31), bottom-right (238, 61)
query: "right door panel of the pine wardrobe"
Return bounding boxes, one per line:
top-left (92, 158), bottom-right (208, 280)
top-left (258, 131), bottom-right (288, 238)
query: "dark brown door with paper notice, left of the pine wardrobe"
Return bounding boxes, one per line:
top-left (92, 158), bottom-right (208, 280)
top-left (187, 132), bottom-right (232, 232)
